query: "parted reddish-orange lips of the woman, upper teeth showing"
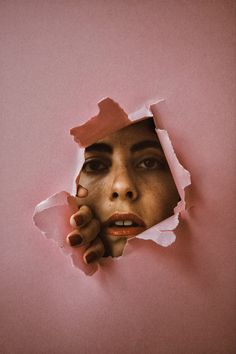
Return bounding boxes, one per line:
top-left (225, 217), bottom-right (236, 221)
top-left (103, 213), bottom-right (146, 237)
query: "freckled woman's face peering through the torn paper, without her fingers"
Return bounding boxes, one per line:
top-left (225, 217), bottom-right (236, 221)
top-left (78, 120), bottom-right (179, 256)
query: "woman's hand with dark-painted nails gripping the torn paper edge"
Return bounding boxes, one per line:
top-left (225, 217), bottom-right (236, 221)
top-left (67, 186), bottom-right (105, 264)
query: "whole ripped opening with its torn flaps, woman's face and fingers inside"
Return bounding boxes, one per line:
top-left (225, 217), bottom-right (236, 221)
top-left (34, 98), bottom-right (190, 274)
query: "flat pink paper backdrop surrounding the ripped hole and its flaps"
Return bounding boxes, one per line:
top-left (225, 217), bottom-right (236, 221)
top-left (0, 0), bottom-right (236, 354)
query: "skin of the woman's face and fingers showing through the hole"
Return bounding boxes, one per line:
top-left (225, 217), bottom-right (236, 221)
top-left (67, 119), bottom-right (179, 263)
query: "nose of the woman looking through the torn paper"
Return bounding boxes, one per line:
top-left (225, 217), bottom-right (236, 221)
top-left (110, 168), bottom-right (138, 201)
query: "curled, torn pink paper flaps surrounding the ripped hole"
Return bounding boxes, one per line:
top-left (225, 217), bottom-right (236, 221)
top-left (33, 98), bottom-right (191, 275)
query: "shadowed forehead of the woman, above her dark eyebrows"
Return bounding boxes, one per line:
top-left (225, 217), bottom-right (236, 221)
top-left (97, 120), bottom-right (158, 146)
